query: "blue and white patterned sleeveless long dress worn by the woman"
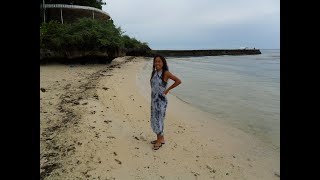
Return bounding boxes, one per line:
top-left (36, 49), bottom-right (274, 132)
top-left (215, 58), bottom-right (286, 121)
top-left (150, 70), bottom-right (168, 136)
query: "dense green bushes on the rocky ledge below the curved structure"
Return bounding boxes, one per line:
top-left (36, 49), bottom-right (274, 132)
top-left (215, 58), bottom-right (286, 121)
top-left (40, 18), bottom-right (150, 54)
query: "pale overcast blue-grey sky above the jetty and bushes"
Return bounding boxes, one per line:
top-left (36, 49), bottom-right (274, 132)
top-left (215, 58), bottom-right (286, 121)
top-left (102, 0), bottom-right (280, 50)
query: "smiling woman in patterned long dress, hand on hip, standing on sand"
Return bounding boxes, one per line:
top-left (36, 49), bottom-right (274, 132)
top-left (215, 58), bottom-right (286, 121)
top-left (150, 55), bottom-right (181, 150)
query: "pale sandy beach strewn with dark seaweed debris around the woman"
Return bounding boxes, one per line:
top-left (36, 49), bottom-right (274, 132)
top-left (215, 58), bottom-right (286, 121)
top-left (40, 56), bottom-right (280, 180)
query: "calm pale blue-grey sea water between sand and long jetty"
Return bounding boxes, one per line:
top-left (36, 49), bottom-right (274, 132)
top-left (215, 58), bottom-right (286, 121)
top-left (139, 49), bottom-right (280, 150)
